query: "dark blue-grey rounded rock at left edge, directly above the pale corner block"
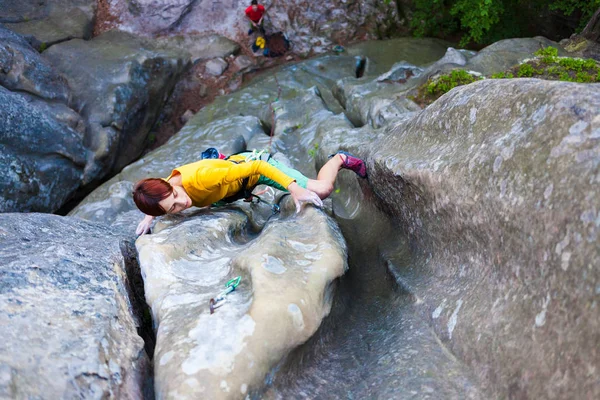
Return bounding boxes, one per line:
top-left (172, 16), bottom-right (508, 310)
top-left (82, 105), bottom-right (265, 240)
top-left (0, 87), bottom-right (89, 212)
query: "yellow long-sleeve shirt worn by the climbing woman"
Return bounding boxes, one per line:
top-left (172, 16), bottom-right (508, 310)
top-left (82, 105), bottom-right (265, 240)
top-left (167, 156), bottom-right (295, 207)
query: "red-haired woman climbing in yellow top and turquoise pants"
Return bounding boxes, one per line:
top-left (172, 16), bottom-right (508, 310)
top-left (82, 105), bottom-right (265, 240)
top-left (133, 149), bottom-right (367, 235)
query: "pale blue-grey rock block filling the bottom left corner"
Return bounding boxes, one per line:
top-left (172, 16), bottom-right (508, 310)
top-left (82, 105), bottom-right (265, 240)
top-left (0, 214), bottom-right (150, 399)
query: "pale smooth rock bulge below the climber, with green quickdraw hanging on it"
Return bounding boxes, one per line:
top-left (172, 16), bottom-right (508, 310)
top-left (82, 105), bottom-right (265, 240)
top-left (136, 209), bottom-right (346, 399)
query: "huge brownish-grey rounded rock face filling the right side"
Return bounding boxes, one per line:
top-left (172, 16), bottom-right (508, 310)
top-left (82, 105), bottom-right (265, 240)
top-left (360, 80), bottom-right (600, 398)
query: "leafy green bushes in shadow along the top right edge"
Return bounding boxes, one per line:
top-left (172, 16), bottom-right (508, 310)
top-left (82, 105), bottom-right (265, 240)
top-left (408, 0), bottom-right (600, 45)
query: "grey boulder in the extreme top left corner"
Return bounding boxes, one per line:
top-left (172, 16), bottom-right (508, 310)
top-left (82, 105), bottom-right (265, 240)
top-left (0, 0), bottom-right (96, 50)
